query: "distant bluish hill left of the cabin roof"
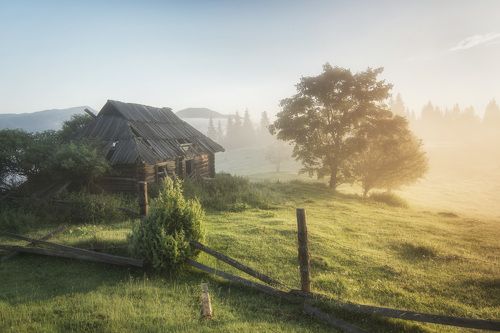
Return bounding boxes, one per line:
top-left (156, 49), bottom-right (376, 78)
top-left (0, 106), bottom-right (97, 132)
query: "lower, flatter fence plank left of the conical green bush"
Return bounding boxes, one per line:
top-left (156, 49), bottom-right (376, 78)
top-left (0, 244), bottom-right (143, 267)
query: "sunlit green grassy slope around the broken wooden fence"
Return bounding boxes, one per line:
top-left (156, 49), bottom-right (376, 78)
top-left (0, 183), bottom-right (500, 332)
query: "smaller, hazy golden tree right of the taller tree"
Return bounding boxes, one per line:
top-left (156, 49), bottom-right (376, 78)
top-left (354, 116), bottom-right (428, 197)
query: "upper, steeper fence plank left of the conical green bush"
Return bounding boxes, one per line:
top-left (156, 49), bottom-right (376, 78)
top-left (0, 232), bottom-right (143, 267)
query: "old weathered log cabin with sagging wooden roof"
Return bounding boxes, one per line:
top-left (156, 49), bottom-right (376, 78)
top-left (80, 100), bottom-right (224, 192)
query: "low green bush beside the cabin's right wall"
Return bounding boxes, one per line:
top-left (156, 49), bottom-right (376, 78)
top-left (184, 173), bottom-right (273, 211)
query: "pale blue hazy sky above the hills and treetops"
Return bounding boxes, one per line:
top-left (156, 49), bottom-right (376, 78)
top-left (0, 0), bottom-right (500, 115)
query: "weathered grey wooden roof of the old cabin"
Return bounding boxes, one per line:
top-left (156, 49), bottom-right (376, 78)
top-left (81, 100), bottom-right (224, 164)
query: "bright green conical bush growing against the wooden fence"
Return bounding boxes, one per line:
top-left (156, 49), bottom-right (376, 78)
top-left (129, 178), bottom-right (204, 271)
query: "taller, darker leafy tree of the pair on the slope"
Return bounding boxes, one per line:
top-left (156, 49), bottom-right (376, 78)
top-left (270, 64), bottom-right (392, 189)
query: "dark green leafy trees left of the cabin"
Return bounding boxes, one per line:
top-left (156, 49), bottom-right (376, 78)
top-left (0, 117), bottom-right (109, 190)
